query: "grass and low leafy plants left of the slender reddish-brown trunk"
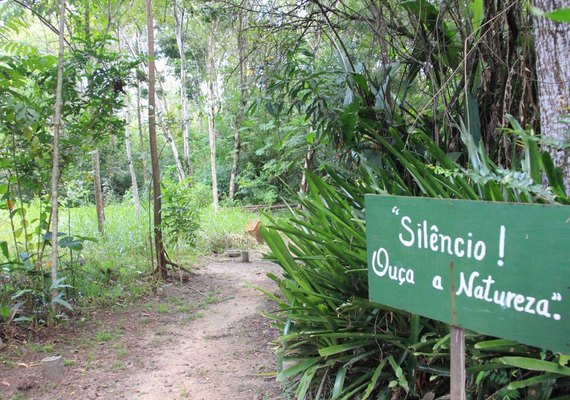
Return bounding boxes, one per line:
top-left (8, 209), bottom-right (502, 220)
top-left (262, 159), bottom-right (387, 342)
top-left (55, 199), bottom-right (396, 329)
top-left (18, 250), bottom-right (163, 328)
top-left (0, 202), bottom-right (153, 335)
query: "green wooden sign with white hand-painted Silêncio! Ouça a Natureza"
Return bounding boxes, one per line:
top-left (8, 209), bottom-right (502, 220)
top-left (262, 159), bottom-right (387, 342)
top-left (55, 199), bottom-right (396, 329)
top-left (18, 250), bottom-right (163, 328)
top-left (366, 195), bottom-right (570, 354)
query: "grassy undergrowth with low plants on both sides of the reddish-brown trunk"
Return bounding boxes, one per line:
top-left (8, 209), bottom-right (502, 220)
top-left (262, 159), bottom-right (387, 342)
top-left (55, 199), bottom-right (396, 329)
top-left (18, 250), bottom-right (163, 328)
top-left (0, 201), bottom-right (266, 338)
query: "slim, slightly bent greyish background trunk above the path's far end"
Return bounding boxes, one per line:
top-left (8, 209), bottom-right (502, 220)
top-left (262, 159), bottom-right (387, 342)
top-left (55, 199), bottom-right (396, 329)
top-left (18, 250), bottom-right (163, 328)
top-left (229, 9), bottom-right (247, 200)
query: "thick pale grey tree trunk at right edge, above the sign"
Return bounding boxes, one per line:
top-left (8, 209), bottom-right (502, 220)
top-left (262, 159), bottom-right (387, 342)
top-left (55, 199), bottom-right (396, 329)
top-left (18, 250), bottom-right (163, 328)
top-left (534, 0), bottom-right (570, 194)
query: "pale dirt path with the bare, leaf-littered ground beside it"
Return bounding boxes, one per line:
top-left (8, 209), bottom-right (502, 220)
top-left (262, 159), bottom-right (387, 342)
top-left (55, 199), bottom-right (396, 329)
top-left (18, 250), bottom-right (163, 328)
top-left (0, 253), bottom-right (283, 400)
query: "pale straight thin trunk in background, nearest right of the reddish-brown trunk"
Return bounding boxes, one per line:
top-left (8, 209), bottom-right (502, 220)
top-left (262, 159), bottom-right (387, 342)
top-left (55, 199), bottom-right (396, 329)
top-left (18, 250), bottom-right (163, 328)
top-left (208, 20), bottom-right (219, 211)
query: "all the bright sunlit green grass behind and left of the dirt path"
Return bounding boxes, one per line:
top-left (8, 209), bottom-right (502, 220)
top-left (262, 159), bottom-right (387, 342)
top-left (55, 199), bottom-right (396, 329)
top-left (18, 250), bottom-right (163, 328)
top-left (0, 201), bottom-right (265, 328)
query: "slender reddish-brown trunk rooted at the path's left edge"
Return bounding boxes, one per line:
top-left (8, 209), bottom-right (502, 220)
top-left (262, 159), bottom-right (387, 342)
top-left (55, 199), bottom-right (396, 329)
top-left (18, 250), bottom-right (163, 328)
top-left (146, 0), bottom-right (168, 279)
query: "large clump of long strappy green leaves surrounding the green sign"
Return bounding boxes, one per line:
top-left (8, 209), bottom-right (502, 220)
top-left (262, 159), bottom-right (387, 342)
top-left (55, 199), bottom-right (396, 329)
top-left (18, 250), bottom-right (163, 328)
top-left (264, 121), bottom-right (570, 400)
